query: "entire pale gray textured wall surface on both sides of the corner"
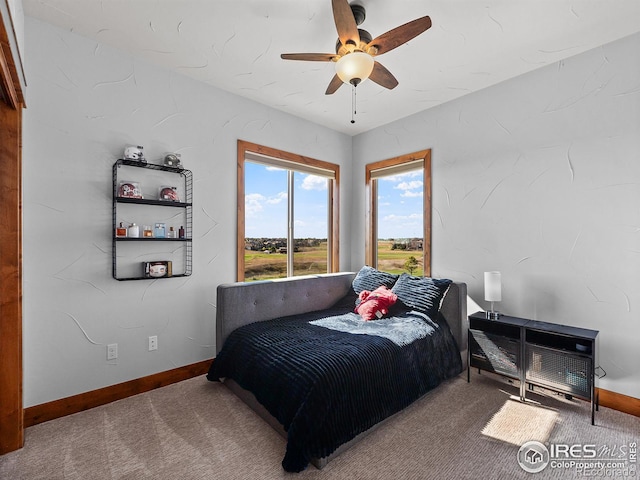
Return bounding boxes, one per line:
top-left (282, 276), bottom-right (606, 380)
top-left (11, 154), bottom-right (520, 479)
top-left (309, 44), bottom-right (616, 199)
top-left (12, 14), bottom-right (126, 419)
top-left (23, 17), bottom-right (640, 406)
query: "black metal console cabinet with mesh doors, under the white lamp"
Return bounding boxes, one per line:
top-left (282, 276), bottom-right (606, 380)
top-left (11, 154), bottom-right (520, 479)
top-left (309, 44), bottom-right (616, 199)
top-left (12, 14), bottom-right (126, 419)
top-left (467, 312), bottom-right (598, 425)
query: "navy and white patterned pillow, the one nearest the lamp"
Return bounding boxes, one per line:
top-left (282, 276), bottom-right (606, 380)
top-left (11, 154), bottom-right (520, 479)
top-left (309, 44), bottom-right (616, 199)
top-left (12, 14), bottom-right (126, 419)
top-left (391, 273), bottom-right (451, 320)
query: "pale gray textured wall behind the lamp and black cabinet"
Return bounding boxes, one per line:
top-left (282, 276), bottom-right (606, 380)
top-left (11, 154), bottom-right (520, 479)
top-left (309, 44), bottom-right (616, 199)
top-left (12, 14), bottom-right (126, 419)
top-left (351, 35), bottom-right (640, 398)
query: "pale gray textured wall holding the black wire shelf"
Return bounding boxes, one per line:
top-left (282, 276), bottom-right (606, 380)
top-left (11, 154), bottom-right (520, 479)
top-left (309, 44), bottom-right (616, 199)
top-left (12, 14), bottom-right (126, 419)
top-left (23, 17), bottom-right (351, 407)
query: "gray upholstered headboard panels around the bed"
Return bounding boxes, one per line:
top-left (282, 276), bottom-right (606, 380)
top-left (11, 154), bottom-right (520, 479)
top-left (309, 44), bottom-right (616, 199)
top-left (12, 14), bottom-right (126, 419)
top-left (216, 272), bottom-right (468, 358)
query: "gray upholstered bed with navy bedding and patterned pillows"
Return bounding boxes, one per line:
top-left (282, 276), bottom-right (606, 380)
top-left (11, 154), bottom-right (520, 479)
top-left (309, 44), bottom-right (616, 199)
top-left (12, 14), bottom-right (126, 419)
top-left (207, 267), bottom-right (467, 472)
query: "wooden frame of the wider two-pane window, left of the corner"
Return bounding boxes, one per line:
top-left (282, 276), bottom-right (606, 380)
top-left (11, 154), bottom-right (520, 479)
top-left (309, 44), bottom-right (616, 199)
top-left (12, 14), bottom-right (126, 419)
top-left (236, 140), bottom-right (340, 282)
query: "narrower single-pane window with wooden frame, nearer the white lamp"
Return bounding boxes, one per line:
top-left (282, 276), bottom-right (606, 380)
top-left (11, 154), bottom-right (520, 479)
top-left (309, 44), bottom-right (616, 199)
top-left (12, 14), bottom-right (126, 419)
top-left (365, 150), bottom-right (431, 276)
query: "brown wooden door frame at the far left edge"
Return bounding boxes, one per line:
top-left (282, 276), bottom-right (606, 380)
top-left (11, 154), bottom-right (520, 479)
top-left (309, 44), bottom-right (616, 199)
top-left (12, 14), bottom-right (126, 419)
top-left (0, 9), bottom-right (24, 454)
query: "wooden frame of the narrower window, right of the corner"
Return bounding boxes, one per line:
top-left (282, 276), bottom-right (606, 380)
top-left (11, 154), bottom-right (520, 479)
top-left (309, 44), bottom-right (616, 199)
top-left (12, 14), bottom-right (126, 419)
top-left (365, 149), bottom-right (432, 277)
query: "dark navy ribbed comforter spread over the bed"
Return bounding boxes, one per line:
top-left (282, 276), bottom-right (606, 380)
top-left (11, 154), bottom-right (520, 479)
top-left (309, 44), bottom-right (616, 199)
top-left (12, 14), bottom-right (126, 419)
top-left (207, 302), bottom-right (462, 472)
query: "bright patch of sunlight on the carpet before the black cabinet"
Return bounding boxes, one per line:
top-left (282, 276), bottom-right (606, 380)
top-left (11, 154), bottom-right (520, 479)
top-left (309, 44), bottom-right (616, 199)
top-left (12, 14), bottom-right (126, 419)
top-left (482, 400), bottom-right (558, 445)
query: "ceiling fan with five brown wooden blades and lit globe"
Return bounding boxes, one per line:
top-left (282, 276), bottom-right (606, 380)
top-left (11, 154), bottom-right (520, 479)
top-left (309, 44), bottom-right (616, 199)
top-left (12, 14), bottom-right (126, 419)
top-left (280, 0), bottom-right (431, 95)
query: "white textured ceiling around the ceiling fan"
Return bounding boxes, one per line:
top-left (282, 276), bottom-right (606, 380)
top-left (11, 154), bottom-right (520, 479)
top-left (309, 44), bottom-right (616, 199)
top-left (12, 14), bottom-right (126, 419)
top-left (23, 0), bottom-right (640, 135)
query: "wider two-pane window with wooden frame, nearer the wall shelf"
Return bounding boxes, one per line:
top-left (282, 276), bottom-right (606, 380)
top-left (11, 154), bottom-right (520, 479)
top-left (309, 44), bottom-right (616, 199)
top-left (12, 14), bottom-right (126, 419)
top-left (237, 140), bottom-right (340, 281)
